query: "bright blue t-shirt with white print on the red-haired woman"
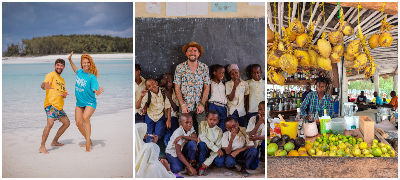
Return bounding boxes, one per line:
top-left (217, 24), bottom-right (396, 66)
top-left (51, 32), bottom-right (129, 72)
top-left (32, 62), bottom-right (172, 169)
top-left (75, 69), bottom-right (99, 109)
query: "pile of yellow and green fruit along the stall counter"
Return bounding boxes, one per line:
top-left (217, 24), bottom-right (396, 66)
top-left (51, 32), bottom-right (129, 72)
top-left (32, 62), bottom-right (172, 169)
top-left (267, 133), bottom-right (396, 157)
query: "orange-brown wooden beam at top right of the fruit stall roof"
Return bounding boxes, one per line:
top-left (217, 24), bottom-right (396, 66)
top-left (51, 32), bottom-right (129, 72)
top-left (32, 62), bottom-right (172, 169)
top-left (326, 2), bottom-right (398, 15)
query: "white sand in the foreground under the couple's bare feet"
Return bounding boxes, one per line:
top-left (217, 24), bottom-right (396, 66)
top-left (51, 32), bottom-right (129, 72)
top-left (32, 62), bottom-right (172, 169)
top-left (2, 109), bottom-right (133, 178)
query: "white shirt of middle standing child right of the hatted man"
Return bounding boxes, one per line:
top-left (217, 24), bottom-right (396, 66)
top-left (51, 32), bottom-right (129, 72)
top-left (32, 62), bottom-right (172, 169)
top-left (225, 80), bottom-right (249, 117)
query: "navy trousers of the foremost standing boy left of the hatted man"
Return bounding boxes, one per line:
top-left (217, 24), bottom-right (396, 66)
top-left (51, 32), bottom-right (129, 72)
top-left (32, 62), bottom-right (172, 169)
top-left (145, 114), bottom-right (165, 143)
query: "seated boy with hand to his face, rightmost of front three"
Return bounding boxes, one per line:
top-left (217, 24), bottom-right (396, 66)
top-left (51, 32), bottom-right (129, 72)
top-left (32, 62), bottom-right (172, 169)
top-left (222, 116), bottom-right (257, 177)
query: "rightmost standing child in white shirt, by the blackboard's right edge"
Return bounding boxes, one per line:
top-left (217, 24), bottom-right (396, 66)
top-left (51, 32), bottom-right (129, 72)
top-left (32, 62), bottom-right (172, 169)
top-left (246, 64), bottom-right (265, 119)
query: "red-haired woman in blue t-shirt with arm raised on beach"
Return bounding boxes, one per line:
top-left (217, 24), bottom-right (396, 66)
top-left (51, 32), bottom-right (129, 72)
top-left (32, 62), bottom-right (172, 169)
top-left (68, 51), bottom-right (104, 152)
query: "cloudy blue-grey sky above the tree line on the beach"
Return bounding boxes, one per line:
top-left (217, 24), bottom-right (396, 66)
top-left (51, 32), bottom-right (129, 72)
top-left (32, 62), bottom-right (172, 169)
top-left (2, 2), bottom-right (133, 51)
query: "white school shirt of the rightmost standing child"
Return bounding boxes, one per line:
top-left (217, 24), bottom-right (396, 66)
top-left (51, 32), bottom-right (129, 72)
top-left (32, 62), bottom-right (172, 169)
top-left (247, 79), bottom-right (265, 113)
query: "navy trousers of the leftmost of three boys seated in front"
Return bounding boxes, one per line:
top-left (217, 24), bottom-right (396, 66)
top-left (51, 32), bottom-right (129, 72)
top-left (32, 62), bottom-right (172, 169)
top-left (167, 141), bottom-right (197, 173)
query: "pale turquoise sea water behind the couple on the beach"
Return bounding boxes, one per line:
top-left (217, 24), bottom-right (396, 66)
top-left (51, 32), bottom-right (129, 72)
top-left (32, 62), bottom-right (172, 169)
top-left (2, 58), bottom-right (133, 132)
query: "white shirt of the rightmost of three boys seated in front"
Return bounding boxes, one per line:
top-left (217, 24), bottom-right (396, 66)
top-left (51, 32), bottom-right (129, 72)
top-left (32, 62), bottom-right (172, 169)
top-left (222, 126), bottom-right (254, 151)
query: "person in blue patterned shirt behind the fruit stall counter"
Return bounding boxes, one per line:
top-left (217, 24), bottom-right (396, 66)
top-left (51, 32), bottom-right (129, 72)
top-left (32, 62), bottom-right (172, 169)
top-left (300, 76), bottom-right (333, 117)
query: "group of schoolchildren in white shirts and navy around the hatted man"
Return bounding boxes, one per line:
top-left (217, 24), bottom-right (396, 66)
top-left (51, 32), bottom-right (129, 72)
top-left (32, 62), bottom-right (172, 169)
top-left (135, 64), bottom-right (265, 176)
